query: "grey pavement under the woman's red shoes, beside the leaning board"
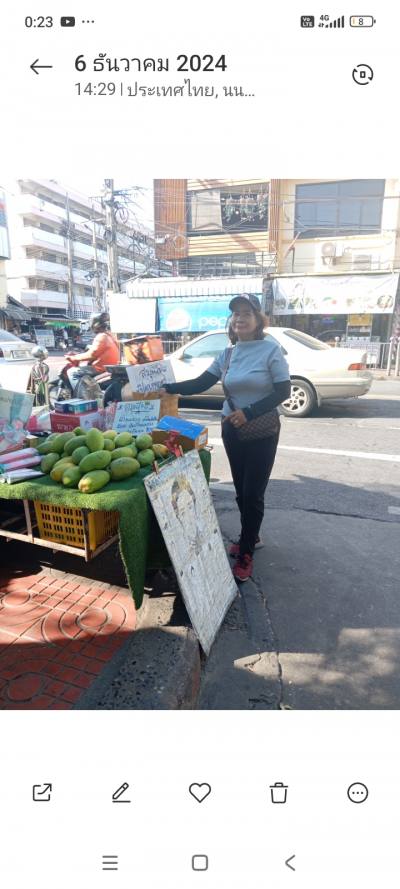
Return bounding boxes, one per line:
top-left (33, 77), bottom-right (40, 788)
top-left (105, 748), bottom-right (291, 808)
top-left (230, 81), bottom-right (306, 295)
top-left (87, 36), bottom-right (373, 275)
top-left (198, 485), bottom-right (400, 710)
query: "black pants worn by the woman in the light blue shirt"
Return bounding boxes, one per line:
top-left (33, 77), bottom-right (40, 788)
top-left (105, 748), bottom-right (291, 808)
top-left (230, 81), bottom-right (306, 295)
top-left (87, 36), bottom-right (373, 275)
top-left (222, 420), bottom-right (279, 555)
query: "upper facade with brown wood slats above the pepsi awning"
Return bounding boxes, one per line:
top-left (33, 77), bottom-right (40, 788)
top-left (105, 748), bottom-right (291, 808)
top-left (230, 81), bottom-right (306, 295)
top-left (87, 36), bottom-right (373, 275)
top-left (154, 179), bottom-right (276, 278)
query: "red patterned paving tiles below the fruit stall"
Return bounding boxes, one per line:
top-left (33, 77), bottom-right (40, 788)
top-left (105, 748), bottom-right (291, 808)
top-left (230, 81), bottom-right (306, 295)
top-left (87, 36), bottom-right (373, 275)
top-left (0, 570), bottom-right (136, 710)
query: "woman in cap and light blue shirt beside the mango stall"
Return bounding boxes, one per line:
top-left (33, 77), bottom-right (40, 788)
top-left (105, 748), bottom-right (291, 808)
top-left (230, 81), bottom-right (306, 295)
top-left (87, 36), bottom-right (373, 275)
top-left (162, 293), bottom-right (290, 582)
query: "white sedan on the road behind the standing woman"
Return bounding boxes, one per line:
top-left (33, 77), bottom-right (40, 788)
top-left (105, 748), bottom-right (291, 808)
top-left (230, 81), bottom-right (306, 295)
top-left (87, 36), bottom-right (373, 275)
top-left (168, 327), bottom-right (373, 417)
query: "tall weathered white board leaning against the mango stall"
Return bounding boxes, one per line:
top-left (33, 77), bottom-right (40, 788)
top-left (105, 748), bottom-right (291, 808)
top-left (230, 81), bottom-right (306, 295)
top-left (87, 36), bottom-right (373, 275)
top-left (144, 450), bottom-right (237, 654)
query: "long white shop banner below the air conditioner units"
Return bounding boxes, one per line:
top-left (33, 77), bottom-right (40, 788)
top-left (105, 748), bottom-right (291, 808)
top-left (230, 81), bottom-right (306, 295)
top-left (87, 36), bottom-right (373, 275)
top-left (273, 274), bottom-right (399, 315)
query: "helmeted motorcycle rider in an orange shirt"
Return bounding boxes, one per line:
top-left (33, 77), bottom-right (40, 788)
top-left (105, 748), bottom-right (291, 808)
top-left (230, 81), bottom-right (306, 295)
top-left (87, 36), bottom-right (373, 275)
top-left (67, 312), bottom-right (119, 392)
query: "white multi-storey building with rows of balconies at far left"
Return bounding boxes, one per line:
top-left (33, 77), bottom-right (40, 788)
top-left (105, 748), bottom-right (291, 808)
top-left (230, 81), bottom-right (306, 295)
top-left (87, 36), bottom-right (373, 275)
top-left (7, 179), bottom-right (151, 319)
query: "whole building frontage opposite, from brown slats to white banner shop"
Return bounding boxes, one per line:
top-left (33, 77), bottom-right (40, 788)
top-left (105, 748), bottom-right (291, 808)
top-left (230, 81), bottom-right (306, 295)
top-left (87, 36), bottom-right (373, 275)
top-left (154, 178), bottom-right (400, 341)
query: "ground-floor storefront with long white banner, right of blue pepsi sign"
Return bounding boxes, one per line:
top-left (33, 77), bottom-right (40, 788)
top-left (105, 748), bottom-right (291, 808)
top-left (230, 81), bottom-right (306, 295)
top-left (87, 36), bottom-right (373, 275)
top-left (273, 273), bottom-right (399, 342)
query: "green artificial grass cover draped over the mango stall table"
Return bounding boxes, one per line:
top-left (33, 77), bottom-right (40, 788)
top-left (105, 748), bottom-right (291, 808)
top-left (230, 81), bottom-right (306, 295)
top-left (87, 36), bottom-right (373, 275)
top-left (0, 450), bottom-right (211, 608)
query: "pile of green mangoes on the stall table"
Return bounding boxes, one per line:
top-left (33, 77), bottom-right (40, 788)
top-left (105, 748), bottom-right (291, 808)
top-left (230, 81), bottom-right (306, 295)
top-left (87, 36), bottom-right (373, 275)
top-left (37, 427), bottom-right (168, 494)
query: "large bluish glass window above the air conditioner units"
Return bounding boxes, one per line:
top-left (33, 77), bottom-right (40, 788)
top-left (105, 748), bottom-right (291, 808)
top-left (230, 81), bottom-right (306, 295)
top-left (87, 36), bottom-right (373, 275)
top-left (294, 179), bottom-right (385, 238)
